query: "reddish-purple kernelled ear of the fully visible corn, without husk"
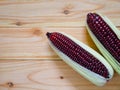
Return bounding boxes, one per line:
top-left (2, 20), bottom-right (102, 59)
top-left (47, 32), bottom-right (109, 78)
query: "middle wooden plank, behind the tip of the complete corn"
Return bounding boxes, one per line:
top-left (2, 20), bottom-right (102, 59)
top-left (0, 27), bottom-right (101, 59)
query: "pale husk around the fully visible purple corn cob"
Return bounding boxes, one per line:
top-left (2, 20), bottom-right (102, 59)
top-left (49, 33), bottom-right (114, 86)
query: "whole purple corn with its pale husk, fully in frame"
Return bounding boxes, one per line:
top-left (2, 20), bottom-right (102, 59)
top-left (46, 32), bottom-right (113, 86)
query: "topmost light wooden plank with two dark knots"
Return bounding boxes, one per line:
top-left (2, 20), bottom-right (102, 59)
top-left (0, 0), bottom-right (120, 28)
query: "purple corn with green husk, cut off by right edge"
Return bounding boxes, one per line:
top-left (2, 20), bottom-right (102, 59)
top-left (86, 13), bottom-right (120, 74)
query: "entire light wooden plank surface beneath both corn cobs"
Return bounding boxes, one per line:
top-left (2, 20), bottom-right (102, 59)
top-left (0, 0), bottom-right (120, 90)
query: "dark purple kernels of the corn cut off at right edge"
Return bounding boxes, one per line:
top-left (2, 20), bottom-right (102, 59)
top-left (87, 13), bottom-right (120, 63)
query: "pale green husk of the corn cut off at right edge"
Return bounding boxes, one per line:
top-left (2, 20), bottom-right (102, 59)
top-left (86, 14), bottom-right (120, 74)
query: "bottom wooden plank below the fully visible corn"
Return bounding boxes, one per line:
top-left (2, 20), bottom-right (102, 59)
top-left (0, 60), bottom-right (120, 90)
